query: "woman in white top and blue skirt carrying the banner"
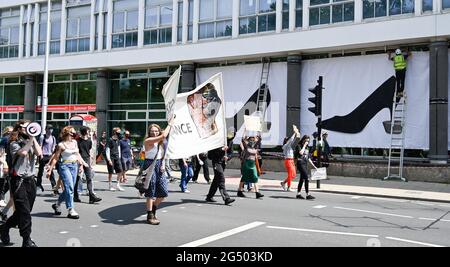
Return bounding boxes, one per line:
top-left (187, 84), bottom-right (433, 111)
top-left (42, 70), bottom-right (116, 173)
top-left (143, 119), bottom-right (173, 225)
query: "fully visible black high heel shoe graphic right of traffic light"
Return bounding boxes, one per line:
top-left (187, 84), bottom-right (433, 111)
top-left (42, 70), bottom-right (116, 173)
top-left (321, 76), bottom-right (395, 134)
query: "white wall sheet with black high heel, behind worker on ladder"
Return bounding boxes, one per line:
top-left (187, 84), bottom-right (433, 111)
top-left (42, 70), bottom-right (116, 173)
top-left (300, 52), bottom-right (428, 149)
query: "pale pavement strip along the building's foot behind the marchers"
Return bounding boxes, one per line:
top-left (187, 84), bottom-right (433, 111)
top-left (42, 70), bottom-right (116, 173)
top-left (94, 164), bottom-right (450, 203)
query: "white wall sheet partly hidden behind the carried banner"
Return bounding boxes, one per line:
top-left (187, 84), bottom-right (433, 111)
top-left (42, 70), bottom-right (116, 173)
top-left (197, 62), bottom-right (287, 147)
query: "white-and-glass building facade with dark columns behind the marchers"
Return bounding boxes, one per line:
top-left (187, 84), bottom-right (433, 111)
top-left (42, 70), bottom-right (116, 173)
top-left (0, 0), bottom-right (450, 161)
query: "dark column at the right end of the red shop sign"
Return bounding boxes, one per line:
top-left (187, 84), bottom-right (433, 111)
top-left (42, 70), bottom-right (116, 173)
top-left (95, 70), bottom-right (110, 137)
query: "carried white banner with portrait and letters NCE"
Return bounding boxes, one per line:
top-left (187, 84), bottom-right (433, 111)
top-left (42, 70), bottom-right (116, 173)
top-left (167, 73), bottom-right (227, 159)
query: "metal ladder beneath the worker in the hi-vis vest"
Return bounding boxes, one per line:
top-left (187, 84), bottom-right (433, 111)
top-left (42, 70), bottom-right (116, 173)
top-left (383, 91), bottom-right (408, 182)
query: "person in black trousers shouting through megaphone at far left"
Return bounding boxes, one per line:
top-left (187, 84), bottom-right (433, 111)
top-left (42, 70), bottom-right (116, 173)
top-left (0, 120), bottom-right (42, 247)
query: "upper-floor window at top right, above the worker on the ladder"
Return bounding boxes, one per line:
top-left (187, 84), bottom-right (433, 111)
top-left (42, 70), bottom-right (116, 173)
top-left (363, 0), bottom-right (414, 19)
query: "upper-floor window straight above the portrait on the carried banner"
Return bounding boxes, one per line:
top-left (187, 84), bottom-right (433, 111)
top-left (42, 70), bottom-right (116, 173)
top-left (198, 0), bottom-right (233, 39)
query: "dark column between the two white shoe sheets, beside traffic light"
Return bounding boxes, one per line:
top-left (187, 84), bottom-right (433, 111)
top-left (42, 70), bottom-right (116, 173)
top-left (286, 55), bottom-right (302, 136)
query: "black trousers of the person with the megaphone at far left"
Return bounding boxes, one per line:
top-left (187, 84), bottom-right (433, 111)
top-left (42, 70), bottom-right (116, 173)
top-left (5, 177), bottom-right (36, 240)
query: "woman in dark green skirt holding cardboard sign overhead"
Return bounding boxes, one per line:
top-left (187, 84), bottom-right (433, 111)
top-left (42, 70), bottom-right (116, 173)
top-left (237, 130), bottom-right (264, 198)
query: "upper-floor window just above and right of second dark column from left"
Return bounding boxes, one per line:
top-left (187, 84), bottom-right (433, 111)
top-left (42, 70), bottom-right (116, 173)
top-left (112, 0), bottom-right (139, 48)
